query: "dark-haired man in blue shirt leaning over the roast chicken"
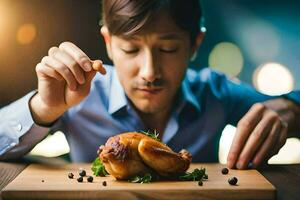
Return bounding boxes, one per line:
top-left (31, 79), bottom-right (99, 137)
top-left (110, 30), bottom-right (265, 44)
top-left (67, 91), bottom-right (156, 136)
top-left (0, 0), bottom-right (300, 169)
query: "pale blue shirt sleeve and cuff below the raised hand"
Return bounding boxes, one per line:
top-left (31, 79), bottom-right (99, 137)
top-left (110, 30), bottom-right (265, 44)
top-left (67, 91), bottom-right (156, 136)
top-left (0, 91), bottom-right (62, 160)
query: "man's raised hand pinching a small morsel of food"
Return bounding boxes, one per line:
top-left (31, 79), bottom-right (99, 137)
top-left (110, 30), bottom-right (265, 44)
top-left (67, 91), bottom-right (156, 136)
top-left (29, 42), bottom-right (106, 124)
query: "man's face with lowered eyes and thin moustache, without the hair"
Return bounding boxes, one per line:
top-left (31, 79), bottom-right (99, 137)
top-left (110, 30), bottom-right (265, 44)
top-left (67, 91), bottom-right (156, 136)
top-left (106, 13), bottom-right (191, 114)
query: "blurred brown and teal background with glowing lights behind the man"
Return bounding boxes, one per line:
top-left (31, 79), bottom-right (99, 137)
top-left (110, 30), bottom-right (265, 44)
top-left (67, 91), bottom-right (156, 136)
top-left (0, 0), bottom-right (300, 163)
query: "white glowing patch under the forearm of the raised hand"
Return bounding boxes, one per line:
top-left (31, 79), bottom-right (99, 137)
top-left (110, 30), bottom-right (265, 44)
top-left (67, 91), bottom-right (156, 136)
top-left (30, 131), bottom-right (70, 157)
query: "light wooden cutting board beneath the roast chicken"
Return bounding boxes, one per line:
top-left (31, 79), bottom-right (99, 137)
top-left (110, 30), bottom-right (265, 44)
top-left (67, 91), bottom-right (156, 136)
top-left (2, 164), bottom-right (275, 200)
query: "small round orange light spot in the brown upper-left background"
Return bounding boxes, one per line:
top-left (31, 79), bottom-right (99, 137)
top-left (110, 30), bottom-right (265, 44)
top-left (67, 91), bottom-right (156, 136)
top-left (17, 24), bottom-right (36, 45)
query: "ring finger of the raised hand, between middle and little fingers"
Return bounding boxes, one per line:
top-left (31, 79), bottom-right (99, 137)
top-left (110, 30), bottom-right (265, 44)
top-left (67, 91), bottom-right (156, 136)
top-left (42, 56), bottom-right (77, 91)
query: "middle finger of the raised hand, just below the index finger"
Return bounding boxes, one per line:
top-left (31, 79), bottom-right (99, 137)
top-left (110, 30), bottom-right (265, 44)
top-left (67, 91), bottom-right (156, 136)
top-left (52, 49), bottom-right (85, 84)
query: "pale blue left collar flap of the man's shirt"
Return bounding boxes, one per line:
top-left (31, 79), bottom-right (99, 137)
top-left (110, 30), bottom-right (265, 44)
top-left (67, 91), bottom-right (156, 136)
top-left (108, 68), bottom-right (128, 114)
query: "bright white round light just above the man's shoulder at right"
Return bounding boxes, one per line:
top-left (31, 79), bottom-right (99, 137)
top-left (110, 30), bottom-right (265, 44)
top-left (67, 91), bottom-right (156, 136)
top-left (253, 63), bottom-right (294, 95)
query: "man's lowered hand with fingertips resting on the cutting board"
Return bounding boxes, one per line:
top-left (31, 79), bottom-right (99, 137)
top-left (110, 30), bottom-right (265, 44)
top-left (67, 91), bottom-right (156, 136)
top-left (227, 100), bottom-right (289, 169)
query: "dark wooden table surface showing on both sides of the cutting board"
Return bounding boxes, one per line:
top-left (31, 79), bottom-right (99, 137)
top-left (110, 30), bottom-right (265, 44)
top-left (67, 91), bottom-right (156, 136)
top-left (0, 159), bottom-right (300, 200)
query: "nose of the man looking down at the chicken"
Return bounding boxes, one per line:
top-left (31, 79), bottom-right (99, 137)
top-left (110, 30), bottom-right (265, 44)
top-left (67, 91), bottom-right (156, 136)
top-left (140, 50), bottom-right (160, 82)
